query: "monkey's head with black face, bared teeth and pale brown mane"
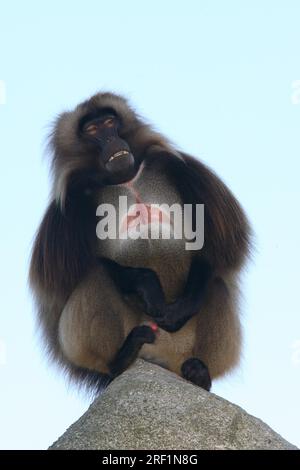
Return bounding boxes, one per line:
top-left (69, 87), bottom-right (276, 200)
top-left (51, 93), bottom-right (180, 207)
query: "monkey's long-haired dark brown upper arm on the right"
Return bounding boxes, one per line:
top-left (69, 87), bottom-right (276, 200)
top-left (177, 154), bottom-right (250, 268)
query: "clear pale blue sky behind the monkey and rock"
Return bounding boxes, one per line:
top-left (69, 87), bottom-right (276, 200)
top-left (0, 0), bottom-right (300, 449)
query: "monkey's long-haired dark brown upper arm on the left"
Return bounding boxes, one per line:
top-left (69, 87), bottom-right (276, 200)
top-left (30, 200), bottom-right (93, 296)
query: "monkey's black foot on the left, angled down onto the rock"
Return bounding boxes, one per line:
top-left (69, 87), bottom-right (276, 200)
top-left (108, 325), bottom-right (155, 377)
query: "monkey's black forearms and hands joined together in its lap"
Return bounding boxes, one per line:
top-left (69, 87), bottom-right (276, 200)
top-left (103, 258), bottom-right (211, 332)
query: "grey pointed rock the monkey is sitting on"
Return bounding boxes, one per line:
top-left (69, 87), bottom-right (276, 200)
top-left (51, 360), bottom-right (296, 450)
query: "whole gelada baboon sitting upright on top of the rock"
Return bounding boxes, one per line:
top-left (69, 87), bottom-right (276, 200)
top-left (30, 93), bottom-right (250, 390)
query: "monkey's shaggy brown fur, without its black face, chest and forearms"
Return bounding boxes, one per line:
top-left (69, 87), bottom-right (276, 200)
top-left (30, 93), bottom-right (249, 385)
